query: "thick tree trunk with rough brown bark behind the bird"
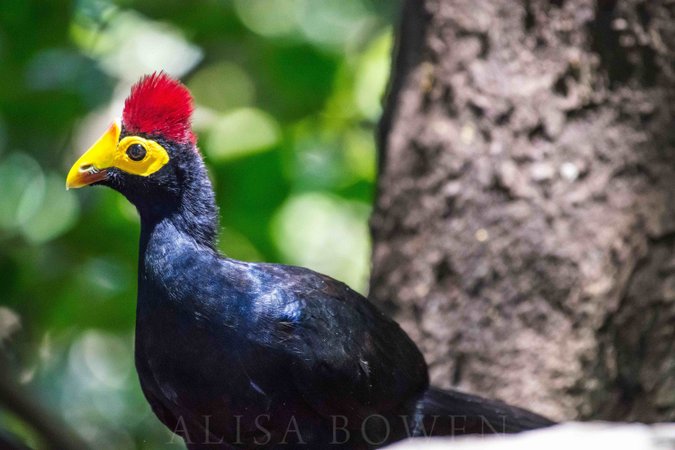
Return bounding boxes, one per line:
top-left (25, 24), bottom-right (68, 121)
top-left (371, 0), bottom-right (675, 421)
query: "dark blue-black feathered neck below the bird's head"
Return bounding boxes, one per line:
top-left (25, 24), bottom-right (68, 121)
top-left (137, 161), bottom-right (219, 251)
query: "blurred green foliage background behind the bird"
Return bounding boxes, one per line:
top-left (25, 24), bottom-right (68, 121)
top-left (0, 0), bottom-right (398, 449)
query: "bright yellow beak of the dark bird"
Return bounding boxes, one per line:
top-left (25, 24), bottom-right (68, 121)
top-left (66, 120), bottom-right (122, 189)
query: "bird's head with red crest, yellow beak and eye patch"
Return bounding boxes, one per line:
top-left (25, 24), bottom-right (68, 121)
top-left (66, 73), bottom-right (203, 210)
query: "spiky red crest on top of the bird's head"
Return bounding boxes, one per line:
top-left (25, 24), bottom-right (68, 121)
top-left (122, 72), bottom-right (196, 144)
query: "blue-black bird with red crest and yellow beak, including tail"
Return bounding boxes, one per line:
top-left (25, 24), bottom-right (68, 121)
top-left (66, 72), bottom-right (553, 450)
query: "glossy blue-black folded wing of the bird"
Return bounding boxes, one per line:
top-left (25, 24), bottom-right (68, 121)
top-left (248, 266), bottom-right (428, 419)
